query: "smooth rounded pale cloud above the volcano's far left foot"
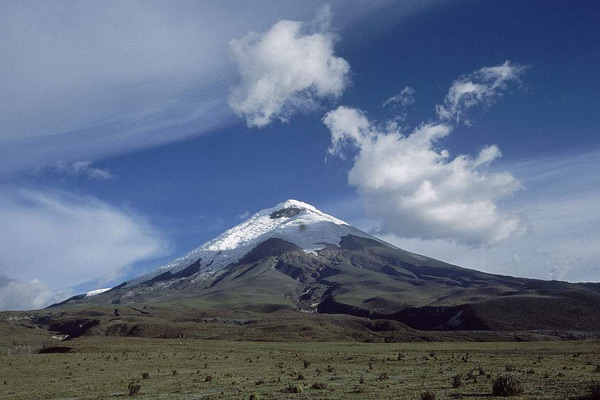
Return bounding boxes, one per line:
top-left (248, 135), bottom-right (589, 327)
top-left (0, 187), bottom-right (167, 310)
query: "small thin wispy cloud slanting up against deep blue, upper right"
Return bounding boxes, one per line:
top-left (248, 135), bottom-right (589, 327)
top-left (436, 61), bottom-right (525, 124)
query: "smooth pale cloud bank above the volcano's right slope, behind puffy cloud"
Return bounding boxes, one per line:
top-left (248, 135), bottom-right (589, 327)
top-left (381, 152), bottom-right (600, 282)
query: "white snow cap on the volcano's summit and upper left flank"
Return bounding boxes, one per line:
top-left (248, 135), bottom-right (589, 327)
top-left (127, 200), bottom-right (371, 286)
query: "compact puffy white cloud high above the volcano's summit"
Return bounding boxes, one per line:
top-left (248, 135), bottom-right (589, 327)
top-left (229, 8), bottom-right (350, 127)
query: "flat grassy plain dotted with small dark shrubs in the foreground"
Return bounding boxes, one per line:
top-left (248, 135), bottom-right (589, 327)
top-left (0, 337), bottom-right (600, 399)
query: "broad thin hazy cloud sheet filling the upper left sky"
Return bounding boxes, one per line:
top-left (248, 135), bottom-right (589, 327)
top-left (0, 0), bottom-right (432, 173)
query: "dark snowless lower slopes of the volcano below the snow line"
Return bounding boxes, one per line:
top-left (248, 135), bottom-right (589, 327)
top-left (62, 235), bottom-right (600, 331)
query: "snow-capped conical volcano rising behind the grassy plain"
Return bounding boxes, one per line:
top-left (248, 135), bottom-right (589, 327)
top-left (49, 200), bottom-right (600, 335)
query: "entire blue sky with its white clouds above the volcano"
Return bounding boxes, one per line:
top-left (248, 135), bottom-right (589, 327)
top-left (0, 1), bottom-right (600, 309)
